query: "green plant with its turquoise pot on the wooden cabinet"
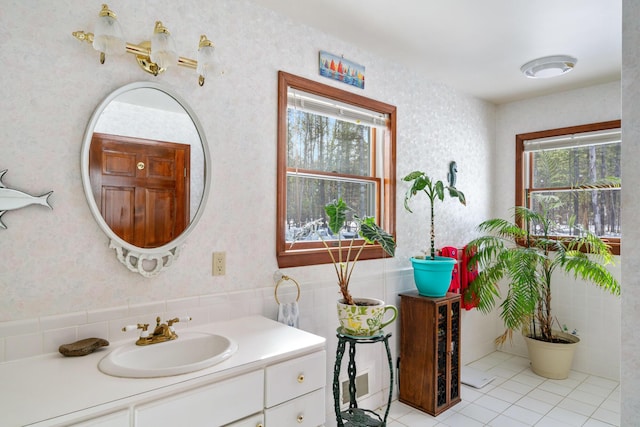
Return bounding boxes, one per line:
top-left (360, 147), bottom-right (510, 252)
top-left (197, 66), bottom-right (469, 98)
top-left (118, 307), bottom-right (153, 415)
top-left (402, 168), bottom-right (467, 297)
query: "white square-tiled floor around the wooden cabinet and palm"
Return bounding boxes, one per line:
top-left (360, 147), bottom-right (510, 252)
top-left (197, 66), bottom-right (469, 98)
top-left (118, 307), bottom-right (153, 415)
top-left (382, 352), bottom-right (620, 427)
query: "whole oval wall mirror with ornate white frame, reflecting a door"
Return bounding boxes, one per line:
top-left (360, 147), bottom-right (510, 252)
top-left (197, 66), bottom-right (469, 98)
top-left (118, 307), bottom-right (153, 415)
top-left (81, 82), bottom-right (210, 277)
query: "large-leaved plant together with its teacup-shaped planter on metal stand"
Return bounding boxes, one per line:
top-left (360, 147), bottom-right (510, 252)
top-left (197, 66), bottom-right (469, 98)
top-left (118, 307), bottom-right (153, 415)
top-left (294, 198), bottom-right (398, 336)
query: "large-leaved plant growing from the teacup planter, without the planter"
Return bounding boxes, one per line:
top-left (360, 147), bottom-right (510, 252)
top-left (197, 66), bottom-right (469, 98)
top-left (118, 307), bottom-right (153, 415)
top-left (294, 198), bottom-right (396, 305)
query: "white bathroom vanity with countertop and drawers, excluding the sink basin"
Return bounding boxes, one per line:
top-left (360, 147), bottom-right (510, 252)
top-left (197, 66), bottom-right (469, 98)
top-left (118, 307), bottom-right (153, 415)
top-left (0, 316), bottom-right (327, 427)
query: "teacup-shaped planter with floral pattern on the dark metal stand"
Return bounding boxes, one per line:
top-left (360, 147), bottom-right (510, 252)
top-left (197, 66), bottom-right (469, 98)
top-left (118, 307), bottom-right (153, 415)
top-left (337, 298), bottom-right (398, 337)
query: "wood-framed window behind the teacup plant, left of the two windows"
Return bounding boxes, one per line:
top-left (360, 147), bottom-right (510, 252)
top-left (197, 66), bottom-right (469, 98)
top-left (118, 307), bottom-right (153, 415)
top-left (276, 71), bottom-right (396, 267)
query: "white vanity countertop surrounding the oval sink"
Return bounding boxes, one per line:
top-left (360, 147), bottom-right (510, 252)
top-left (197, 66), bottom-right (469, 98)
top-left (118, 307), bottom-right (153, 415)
top-left (0, 316), bottom-right (326, 426)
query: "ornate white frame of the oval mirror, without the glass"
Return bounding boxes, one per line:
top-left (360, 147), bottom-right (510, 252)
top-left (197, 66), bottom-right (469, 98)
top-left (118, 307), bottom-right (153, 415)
top-left (80, 82), bottom-right (211, 277)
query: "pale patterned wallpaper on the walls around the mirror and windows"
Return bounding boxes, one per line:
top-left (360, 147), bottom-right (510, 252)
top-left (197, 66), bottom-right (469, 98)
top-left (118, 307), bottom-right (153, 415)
top-left (0, 0), bottom-right (638, 418)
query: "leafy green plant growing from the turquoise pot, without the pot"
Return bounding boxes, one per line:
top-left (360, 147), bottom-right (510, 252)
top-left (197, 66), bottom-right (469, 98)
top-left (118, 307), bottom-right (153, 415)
top-left (402, 171), bottom-right (467, 260)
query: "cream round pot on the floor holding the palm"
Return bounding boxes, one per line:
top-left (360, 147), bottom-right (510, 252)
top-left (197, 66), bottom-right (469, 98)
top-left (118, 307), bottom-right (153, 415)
top-left (524, 331), bottom-right (580, 380)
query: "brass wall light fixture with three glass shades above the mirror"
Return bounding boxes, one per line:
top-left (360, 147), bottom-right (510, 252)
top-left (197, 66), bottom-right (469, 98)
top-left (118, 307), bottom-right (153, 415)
top-left (72, 4), bottom-right (214, 86)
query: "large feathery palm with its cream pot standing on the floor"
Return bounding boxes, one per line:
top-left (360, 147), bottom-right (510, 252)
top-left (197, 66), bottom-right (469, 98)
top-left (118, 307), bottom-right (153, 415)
top-left (467, 196), bottom-right (620, 379)
